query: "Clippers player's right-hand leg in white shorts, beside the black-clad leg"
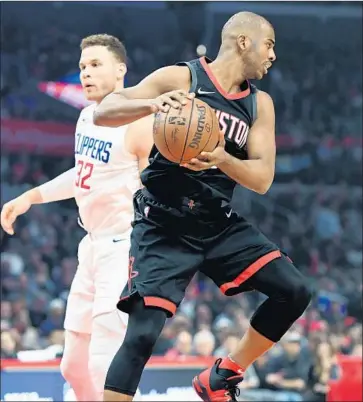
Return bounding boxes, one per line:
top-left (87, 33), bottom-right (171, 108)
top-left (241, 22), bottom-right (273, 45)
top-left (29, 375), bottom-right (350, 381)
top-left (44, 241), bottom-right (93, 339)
top-left (88, 233), bottom-right (142, 401)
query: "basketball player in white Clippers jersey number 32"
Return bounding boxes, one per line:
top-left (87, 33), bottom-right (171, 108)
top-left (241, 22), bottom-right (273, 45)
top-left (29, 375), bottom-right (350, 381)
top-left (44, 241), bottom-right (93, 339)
top-left (1, 35), bottom-right (153, 401)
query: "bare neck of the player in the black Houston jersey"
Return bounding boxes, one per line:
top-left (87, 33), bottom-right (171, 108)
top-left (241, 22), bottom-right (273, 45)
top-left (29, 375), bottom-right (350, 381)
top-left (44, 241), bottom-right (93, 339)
top-left (209, 53), bottom-right (246, 92)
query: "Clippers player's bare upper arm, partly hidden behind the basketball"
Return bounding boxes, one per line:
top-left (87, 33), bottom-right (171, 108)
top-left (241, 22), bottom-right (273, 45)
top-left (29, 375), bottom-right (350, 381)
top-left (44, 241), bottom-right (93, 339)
top-left (126, 115), bottom-right (154, 173)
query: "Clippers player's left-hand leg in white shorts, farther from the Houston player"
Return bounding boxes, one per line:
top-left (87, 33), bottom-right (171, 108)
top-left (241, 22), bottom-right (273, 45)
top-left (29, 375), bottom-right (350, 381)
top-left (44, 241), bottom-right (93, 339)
top-left (60, 236), bottom-right (95, 401)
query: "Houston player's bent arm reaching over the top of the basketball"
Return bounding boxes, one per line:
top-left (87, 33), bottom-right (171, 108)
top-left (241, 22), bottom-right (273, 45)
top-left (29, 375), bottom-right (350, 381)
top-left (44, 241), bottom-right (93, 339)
top-left (93, 66), bottom-right (194, 127)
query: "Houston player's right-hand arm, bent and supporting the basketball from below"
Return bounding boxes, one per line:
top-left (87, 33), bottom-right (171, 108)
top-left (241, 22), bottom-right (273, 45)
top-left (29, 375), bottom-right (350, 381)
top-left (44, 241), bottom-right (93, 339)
top-left (183, 91), bottom-right (276, 194)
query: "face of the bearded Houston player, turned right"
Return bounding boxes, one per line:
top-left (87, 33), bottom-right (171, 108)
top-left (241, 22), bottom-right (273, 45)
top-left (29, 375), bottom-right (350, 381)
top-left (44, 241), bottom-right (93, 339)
top-left (242, 25), bottom-right (276, 80)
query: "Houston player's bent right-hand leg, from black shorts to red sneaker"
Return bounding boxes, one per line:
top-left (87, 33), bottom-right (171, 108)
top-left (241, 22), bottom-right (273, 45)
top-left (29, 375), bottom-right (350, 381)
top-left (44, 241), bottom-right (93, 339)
top-left (193, 219), bottom-right (311, 401)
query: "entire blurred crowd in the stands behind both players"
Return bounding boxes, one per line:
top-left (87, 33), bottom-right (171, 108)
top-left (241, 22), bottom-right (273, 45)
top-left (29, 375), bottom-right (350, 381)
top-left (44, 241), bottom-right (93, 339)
top-left (1, 3), bottom-right (362, 401)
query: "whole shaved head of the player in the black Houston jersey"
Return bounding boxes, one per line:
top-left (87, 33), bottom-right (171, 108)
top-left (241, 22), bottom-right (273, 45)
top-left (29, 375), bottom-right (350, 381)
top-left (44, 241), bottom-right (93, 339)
top-left (220, 12), bottom-right (276, 80)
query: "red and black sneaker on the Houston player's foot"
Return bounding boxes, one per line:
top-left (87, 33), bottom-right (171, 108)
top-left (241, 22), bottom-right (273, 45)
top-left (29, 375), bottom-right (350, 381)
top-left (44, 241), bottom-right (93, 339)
top-left (193, 357), bottom-right (244, 402)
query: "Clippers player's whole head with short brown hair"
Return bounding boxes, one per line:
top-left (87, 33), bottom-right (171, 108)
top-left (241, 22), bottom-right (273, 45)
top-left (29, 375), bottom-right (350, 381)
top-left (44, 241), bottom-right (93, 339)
top-left (79, 34), bottom-right (127, 102)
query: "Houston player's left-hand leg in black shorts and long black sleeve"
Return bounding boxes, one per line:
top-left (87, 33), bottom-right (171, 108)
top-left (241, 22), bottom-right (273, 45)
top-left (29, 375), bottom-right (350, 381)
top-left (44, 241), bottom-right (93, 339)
top-left (104, 193), bottom-right (203, 401)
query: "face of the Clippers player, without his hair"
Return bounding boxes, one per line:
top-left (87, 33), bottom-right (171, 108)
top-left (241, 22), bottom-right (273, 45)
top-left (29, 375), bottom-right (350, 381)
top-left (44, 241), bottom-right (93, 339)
top-left (79, 46), bottom-right (126, 102)
